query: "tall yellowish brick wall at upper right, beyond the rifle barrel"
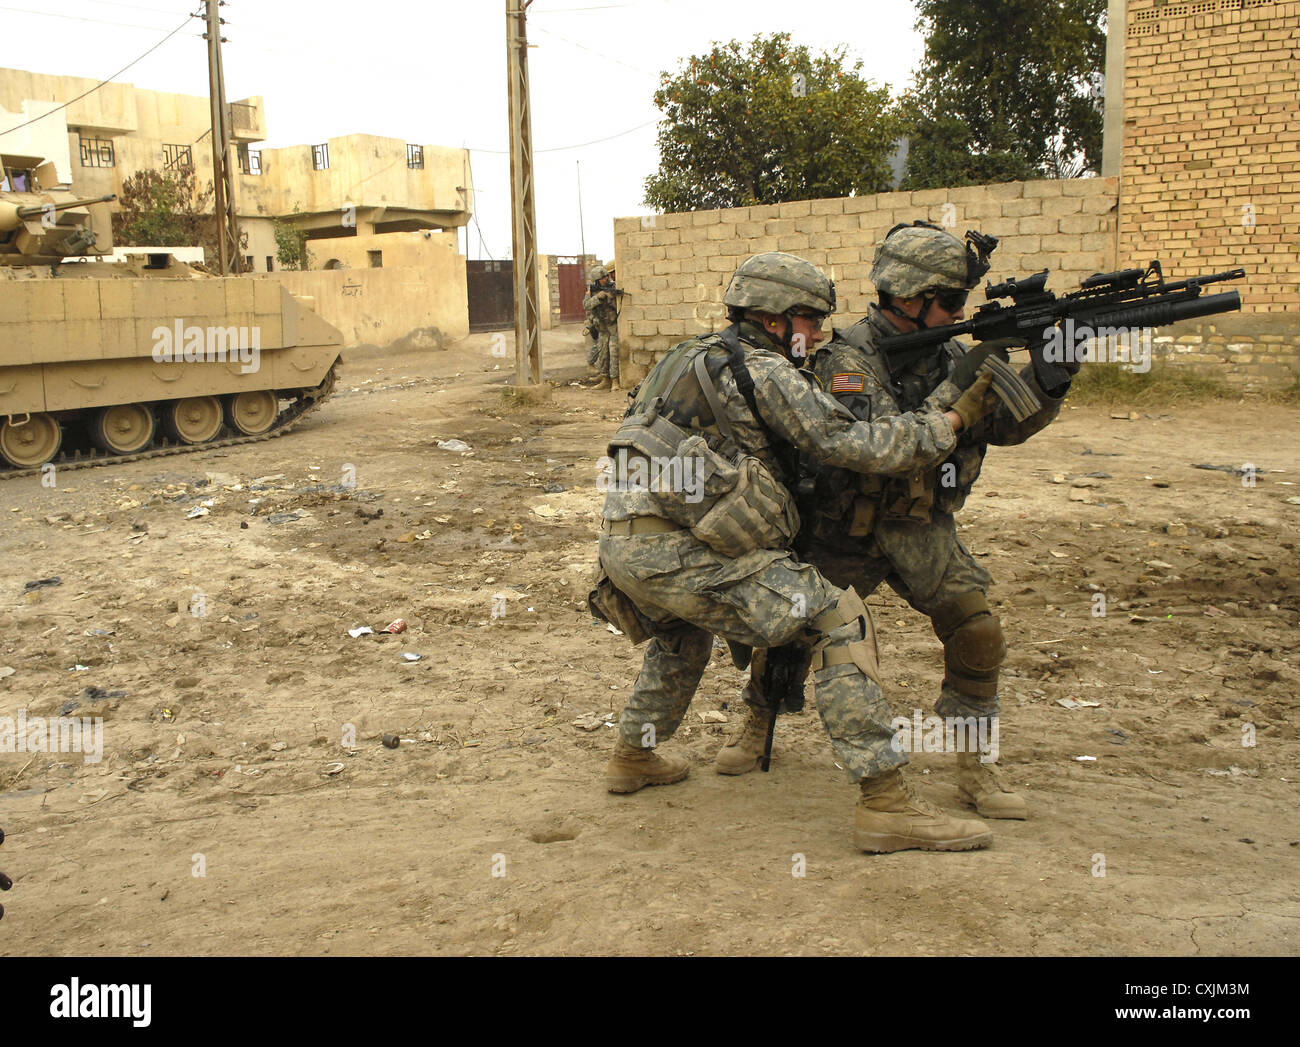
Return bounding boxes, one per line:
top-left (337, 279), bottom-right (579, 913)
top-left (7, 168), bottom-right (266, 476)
top-left (1119, 0), bottom-right (1300, 312)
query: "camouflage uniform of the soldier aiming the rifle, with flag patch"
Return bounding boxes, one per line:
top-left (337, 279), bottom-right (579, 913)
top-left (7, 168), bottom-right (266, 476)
top-left (797, 306), bottom-right (1063, 769)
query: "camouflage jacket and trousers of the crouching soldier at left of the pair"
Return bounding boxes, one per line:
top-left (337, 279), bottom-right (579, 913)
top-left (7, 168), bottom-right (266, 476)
top-left (599, 300), bottom-right (956, 780)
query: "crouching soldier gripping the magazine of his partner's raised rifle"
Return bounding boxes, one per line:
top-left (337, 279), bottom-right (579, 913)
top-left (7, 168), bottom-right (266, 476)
top-left (592, 252), bottom-right (992, 851)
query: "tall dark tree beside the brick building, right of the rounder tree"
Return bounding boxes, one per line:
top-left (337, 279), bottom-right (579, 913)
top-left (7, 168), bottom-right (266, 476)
top-left (902, 0), bottom-right (1106, 189)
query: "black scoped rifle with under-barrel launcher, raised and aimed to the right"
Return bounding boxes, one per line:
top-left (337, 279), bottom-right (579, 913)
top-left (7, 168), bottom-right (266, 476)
top-left (880, 261), bottom-right (1245, 421)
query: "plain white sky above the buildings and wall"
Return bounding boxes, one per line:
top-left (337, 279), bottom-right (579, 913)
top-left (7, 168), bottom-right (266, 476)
top-left (0, 0), bottom-right (923, 258)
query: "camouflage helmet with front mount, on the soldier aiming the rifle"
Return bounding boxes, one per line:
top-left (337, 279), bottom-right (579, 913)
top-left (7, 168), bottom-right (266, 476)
top-left (871, 221), bottom-right (997, 298)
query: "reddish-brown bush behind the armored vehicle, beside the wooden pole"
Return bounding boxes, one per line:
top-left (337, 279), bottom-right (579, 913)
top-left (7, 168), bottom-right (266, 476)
top-left (113, 166), bottom-right (217, 252)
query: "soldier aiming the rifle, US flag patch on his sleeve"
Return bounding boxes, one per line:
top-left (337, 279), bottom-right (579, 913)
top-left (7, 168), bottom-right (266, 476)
top-left (716, 222), bottom-right (1076, 818)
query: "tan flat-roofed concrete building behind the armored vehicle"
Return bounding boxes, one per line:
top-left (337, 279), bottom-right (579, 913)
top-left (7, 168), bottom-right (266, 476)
top-left (0, 69), bottom-right (473, 272)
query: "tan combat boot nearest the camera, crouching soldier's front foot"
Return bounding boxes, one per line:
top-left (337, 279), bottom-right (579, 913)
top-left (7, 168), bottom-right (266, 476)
top-left (853, 770), bottom-right (993, 855)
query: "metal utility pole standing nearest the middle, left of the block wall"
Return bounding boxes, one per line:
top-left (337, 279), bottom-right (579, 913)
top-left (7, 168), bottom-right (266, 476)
top-left (506, 0), bottom-right (542, 386)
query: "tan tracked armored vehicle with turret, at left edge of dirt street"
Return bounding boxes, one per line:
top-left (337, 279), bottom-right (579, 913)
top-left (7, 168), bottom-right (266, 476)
top-left (0, 168), bottom-right (343, 479)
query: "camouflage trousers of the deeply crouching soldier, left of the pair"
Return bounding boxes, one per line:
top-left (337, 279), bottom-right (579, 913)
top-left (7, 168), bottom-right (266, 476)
top-left (601, 531), bottom-right (907, 782)
